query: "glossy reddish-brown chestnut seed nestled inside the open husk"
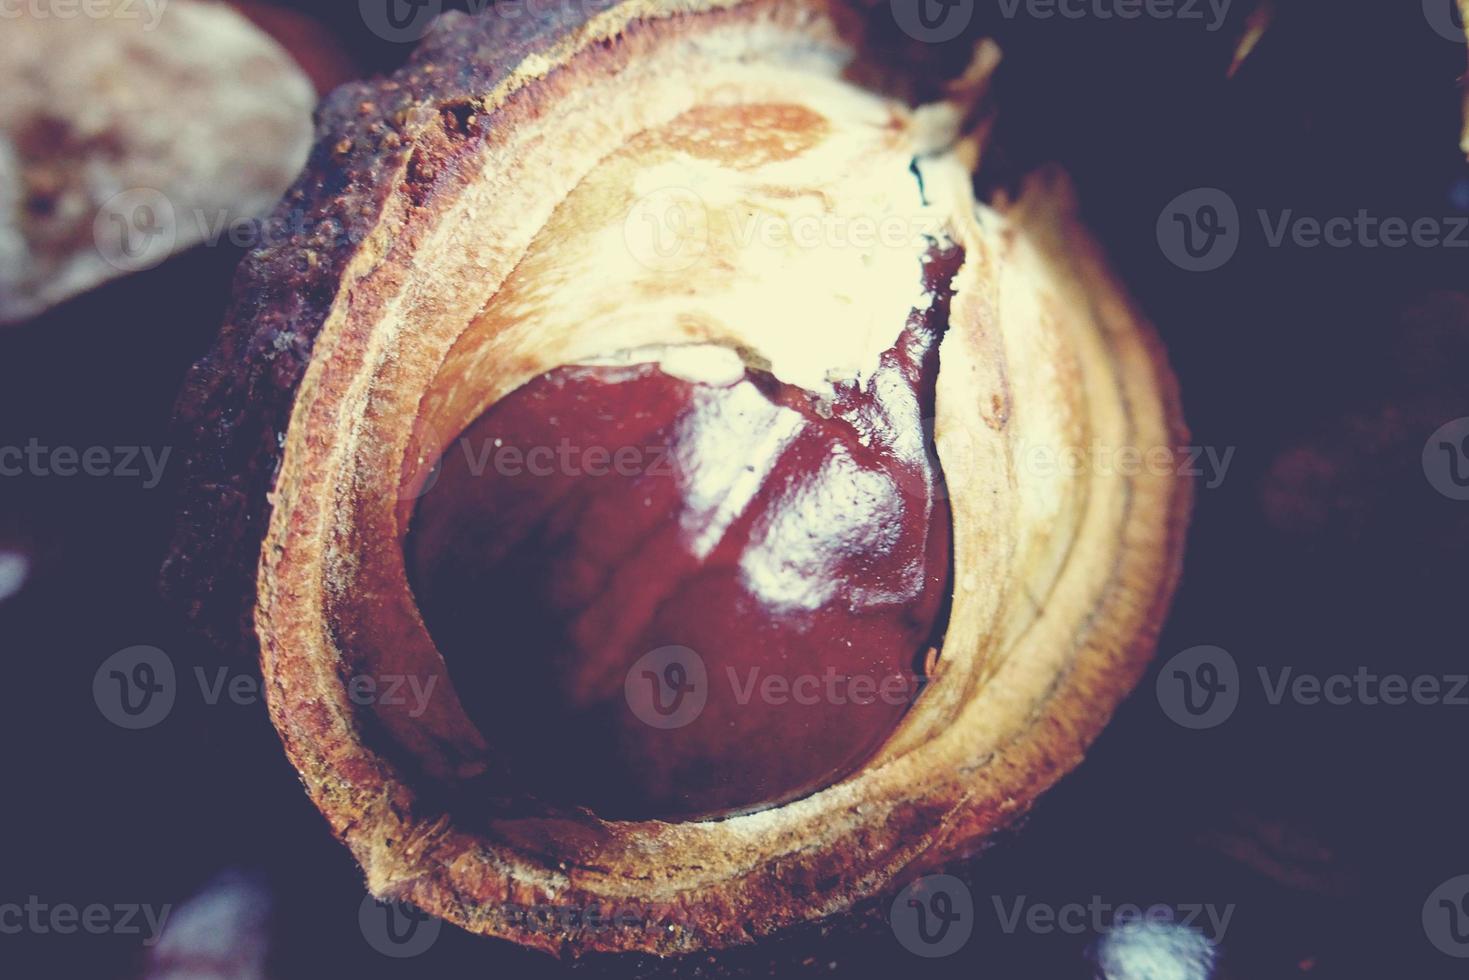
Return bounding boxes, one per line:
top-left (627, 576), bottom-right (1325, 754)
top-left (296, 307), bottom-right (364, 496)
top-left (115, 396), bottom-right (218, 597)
top-left (408, 247), bottom-right (962, 818)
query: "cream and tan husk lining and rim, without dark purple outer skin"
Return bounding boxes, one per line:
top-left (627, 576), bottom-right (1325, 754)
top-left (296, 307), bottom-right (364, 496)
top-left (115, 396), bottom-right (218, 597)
top-left (257, 3), bottom-right (1172, 942)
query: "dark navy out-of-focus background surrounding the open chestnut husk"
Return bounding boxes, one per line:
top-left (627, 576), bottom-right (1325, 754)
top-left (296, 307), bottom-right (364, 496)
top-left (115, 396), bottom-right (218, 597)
top-left (0, 0), bottom-right (1469, 980)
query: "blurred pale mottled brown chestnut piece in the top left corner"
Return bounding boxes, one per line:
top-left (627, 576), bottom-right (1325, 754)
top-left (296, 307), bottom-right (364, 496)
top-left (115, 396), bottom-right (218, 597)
top-left (0, 0), bottom-right (321, 325)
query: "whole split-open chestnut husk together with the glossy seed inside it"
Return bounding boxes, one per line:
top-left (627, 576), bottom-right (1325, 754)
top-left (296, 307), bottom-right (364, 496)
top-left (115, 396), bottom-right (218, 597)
top-left (166, 0), bottom-right (1191, 955)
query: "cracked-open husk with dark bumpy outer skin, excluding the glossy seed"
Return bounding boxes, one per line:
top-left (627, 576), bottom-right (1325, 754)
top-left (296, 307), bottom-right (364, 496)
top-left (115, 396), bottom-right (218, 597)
top-left (167, 0), bottom-right (1190, 954)
